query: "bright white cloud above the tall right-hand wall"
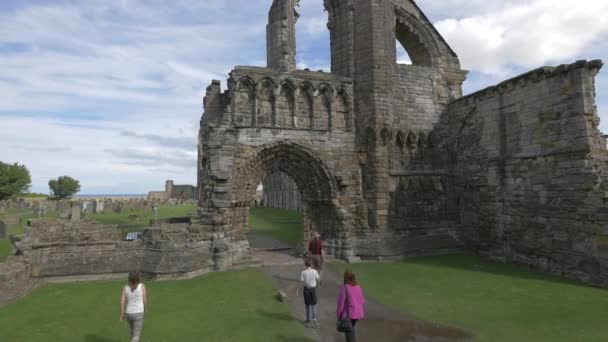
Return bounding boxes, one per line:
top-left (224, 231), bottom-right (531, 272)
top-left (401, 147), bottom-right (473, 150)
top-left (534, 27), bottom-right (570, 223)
top-left (435, 0), bottom-right (608, 74)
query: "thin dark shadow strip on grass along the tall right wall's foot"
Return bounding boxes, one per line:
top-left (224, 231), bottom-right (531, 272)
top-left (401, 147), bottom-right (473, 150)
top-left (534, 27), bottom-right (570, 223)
top-left (401, 254), bottom-right (590, 287)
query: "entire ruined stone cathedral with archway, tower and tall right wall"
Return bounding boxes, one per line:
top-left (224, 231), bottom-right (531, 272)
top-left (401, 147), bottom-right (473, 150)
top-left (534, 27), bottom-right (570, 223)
top-left (198, 0), bottom-right (608, 285)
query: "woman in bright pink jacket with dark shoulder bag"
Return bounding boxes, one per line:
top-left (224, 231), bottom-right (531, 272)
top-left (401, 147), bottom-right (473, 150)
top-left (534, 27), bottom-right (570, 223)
top-left (336, 271), bottom-right (365, 342)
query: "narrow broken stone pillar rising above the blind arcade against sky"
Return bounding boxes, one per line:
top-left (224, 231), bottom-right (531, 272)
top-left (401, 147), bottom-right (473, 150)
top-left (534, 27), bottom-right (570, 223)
top-left (266, 0), bottom-right (299, 72)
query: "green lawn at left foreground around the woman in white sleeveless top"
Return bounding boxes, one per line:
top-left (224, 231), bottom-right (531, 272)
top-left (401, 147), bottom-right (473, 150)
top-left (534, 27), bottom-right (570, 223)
top-left (0, 270), bottom-right (309, 342)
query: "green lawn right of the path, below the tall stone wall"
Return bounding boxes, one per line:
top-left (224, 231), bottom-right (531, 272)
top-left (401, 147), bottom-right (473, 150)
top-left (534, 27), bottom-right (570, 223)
top-left (332, 255), bottom-right (608, 342)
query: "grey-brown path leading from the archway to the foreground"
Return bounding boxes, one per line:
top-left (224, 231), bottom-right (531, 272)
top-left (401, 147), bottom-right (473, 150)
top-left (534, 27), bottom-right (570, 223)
top-left (254, 242), bottom-right (470, 342)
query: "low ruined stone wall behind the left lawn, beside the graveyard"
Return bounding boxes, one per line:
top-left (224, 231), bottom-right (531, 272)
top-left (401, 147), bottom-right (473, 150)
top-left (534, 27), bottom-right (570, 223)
top-left (0, 216), bottom-right (259, 307)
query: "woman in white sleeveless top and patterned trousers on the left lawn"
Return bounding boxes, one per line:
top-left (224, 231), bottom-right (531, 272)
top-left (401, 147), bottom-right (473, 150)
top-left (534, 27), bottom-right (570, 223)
top-left (120, 272), bottom-right (148, 342)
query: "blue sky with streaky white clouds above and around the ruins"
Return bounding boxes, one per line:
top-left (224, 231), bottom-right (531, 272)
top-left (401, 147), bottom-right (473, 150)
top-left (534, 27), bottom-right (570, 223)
top-left (0, 0), bottom-right (608, 193)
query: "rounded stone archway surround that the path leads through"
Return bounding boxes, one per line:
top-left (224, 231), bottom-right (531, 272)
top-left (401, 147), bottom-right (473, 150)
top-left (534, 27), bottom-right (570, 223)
top-left (229, 141), bottom-right (344, 254)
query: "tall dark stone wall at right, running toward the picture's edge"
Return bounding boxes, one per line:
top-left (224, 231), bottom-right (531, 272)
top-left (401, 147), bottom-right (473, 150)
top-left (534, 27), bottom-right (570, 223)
top-left (439, 61), bottom-right (608, 286)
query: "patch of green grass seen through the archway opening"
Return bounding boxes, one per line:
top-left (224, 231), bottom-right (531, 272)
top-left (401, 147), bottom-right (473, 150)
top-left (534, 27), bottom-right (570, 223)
top-left (249, 207), bottom-right (304, 246)
